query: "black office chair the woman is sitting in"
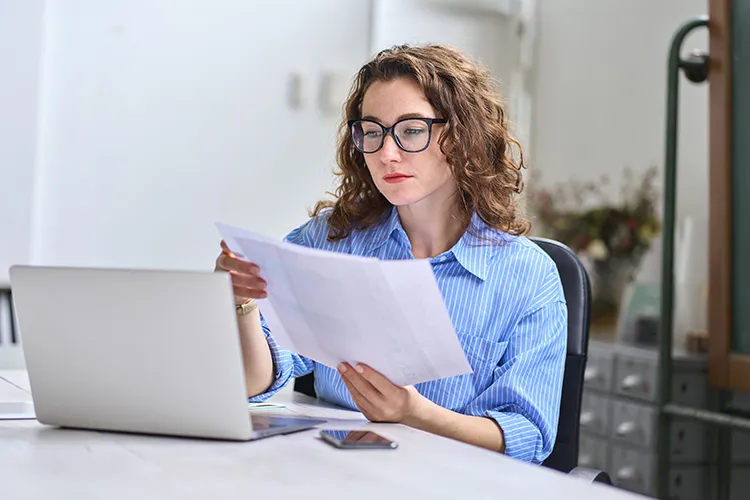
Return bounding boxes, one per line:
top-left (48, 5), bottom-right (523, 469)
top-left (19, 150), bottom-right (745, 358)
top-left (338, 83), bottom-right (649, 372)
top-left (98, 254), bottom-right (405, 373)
top-left (294, 238), bottom-right (612, 484)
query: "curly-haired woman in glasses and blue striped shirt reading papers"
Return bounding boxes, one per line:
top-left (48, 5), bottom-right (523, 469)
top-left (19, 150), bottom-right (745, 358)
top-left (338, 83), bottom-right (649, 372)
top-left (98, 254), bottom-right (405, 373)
top-left (216, 45), bottom-right (567, 463)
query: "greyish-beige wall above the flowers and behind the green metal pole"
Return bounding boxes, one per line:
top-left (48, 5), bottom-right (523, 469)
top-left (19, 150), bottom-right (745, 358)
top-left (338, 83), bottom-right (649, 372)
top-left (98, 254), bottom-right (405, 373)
top-left (531, 0), bottom-right (708, 336)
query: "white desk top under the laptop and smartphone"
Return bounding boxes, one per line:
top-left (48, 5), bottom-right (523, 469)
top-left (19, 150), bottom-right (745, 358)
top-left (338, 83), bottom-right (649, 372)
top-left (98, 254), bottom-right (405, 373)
top-left (0, 371), bottom-right (643, 500)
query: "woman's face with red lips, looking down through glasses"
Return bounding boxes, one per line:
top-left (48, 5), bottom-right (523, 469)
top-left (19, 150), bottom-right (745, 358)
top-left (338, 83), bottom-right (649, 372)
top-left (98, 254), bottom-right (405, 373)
top-left (362, 78), bottom-right (456, 206)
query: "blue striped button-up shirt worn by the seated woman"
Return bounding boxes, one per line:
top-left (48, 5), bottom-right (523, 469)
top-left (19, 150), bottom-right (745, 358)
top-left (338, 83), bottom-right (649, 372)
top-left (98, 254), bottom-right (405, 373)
top-left (251, 206), bottom-right (567, 463)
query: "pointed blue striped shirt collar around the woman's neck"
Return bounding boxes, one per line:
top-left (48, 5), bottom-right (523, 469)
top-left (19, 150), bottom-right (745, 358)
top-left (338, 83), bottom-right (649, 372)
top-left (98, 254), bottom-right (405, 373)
top-left (370, 207), bottom-right (505, 281)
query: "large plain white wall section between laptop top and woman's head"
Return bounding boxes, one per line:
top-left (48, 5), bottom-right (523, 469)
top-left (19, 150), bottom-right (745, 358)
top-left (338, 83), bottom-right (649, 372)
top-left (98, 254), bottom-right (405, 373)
top-left (33, 0), bottom-right (369, 269)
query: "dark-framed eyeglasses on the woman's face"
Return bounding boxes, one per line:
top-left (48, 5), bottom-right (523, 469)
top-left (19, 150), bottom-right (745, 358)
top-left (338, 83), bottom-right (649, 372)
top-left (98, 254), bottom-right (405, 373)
top-left (347, 118), bottom-right (448, 154)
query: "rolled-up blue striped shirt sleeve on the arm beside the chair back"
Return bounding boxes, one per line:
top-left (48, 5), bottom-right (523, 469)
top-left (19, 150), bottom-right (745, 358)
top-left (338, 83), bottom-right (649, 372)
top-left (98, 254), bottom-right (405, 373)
top-left (472, 300), bottom-right (568, 463)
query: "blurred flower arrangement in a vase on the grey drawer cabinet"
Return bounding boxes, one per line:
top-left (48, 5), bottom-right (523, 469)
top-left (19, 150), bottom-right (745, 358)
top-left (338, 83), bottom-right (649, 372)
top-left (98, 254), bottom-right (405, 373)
top-left (529, 167), bottom-right (661, 321)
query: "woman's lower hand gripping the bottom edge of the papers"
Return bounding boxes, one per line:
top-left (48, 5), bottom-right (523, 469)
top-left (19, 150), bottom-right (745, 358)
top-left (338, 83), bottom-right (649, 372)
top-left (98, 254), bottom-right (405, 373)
top-left (339, 363), bottom-right (423, 423)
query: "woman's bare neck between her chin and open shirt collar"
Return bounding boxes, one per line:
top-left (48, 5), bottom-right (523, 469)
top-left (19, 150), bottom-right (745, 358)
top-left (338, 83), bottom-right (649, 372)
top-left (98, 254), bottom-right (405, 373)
top-left (397, 200), bottom-right (466, 259)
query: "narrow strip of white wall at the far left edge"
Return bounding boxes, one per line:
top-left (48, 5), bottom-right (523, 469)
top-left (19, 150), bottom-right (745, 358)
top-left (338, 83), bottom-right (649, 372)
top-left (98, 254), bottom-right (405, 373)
top-left (0, 0), bottom-right (44, 284)
